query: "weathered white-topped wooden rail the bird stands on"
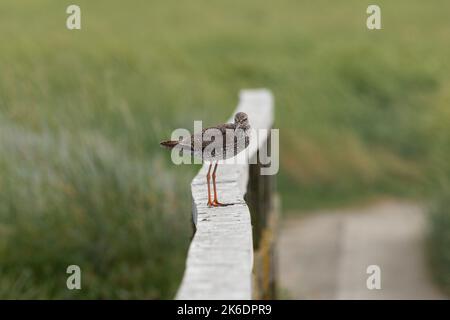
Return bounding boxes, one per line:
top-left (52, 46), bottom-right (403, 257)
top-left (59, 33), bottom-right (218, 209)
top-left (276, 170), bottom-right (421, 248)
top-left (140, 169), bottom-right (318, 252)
top-left (176, 89), bottom-right (278, 299)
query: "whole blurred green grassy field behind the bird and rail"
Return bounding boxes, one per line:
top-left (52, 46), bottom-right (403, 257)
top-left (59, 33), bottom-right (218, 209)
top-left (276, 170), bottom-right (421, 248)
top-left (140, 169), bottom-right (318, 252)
top-left (0, 0), bottom-right (450, 298)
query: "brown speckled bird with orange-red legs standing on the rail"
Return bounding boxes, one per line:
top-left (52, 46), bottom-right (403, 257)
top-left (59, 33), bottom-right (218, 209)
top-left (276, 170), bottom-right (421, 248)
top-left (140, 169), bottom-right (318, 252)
top-left (160, 112), bottom-right (251, 207)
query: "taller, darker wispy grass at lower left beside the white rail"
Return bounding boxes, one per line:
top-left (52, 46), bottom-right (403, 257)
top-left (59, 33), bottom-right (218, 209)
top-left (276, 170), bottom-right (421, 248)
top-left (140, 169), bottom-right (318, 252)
top-left (0, 122), bottom-right (190, 298)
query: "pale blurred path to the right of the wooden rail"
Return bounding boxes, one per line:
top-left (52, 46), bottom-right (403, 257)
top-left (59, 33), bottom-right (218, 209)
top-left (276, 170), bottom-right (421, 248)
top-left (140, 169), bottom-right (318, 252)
top-left (278, 201), bottom-right (445, 299)
